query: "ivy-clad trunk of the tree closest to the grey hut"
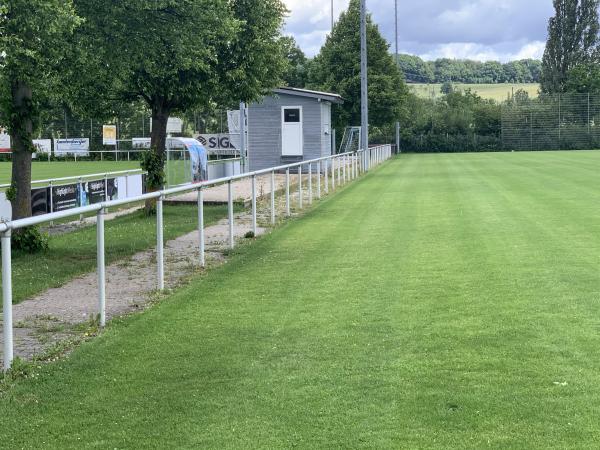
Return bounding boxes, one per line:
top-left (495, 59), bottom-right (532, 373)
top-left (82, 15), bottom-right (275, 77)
top-left (146, 98), bottom-right (171, 214)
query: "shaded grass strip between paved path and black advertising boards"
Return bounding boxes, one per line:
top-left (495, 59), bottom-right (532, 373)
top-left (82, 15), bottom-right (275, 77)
top-left (4, 205), bottom-right (234, 303)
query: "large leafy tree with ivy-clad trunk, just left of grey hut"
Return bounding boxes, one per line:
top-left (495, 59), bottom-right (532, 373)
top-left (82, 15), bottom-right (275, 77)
top-left (75, 0), bottom-right (286, 197)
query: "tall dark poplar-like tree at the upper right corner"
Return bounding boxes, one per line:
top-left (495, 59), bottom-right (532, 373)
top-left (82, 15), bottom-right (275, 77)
top-left (542, 0), bottom-right (600, 93)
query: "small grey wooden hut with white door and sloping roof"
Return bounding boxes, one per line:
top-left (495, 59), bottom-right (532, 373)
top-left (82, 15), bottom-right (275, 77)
top-left (248, 88), bottom-right (343, 171)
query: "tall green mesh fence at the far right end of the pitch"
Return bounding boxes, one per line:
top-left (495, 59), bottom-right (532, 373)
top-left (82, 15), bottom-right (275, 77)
top-left (502, 94), bottom-right (600, 150)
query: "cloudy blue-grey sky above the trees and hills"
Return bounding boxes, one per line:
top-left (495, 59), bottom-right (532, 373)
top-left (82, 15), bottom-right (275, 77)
top-left (284, 0), bottom-right (554, 62)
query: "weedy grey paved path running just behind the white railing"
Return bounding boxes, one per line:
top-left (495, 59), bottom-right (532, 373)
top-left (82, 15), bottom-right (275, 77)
top-left (0, 183), bottom-right (318, 366)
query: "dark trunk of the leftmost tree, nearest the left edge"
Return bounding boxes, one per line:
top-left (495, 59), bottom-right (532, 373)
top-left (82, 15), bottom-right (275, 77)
top-left (11, 81), bottom-right (33, 219)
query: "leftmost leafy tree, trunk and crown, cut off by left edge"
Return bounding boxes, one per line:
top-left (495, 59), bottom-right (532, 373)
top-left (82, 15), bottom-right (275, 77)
top-left (0, 0), bottom-right (80, 219)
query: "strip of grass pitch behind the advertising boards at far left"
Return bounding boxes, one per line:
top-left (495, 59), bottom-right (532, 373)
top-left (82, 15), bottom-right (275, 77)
top-left (0, 161), bottom-right (140, 184)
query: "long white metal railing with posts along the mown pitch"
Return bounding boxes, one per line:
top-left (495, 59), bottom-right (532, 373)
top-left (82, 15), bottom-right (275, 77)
top-left (0, 145), bottom-right (392, 370)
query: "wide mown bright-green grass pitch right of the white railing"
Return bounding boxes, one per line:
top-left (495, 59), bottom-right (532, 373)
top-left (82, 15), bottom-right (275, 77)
top-left (0, 152), bottom-right (600, 449)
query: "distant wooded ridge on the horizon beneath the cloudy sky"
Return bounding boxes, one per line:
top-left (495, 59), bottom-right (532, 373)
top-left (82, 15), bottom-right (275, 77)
top-left (398, 54), bottom-right (542, 84)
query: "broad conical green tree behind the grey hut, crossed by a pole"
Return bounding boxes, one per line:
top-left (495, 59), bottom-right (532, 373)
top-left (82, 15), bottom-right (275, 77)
top-left (310, 0), bottom-right (408, 134)
